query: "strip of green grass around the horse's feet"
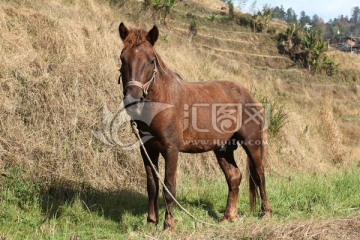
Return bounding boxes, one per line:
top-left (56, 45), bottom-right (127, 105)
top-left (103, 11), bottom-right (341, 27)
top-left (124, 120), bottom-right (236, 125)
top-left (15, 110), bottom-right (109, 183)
top-left (0, 166), bottom-right (360, 239)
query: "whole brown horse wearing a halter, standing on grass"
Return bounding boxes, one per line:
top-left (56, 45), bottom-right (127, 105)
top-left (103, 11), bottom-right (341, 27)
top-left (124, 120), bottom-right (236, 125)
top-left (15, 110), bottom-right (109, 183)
top-left (119, 23), bottom-right (271, 230)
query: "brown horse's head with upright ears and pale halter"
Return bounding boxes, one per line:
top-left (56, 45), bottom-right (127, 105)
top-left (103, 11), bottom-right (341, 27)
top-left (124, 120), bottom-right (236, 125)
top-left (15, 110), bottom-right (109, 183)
top-left (119, 23), bottom-right (159, 113)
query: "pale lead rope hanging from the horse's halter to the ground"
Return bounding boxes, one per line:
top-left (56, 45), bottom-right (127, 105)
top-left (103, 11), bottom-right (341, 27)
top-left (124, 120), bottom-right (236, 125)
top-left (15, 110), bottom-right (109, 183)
top-left (131, 120), bottom-right (221, 227)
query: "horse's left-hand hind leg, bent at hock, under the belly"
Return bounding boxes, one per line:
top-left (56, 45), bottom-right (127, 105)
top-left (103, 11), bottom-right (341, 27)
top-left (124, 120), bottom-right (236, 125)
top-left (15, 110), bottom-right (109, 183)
top-left (214, 146), bottom-right (241, 222)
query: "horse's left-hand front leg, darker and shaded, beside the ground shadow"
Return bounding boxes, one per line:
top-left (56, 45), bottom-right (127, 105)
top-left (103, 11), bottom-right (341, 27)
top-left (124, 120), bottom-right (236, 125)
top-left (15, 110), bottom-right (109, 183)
top-left (141, 148), bottom-right (159, 224)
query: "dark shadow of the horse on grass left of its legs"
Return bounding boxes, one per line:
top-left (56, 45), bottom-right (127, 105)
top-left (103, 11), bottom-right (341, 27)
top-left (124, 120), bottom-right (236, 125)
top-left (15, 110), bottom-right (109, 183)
top-left (40, 181), bottom-right (147, 223)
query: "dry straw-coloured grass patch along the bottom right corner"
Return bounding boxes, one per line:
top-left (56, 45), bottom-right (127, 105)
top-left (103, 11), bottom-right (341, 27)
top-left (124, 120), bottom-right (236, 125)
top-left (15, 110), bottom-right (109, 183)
top-left (177, 215), bottom-right (360, 240)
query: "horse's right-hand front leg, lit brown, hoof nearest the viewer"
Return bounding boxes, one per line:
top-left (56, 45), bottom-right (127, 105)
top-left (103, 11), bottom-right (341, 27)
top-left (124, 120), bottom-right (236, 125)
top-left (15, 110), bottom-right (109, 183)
top-left (163, 147), bottom-right (179, 231)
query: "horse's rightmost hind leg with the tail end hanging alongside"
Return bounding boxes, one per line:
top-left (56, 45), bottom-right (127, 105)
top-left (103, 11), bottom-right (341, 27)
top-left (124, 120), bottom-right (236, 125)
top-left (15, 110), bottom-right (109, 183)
top-left (242, 136), bottom-right (272, 217)
